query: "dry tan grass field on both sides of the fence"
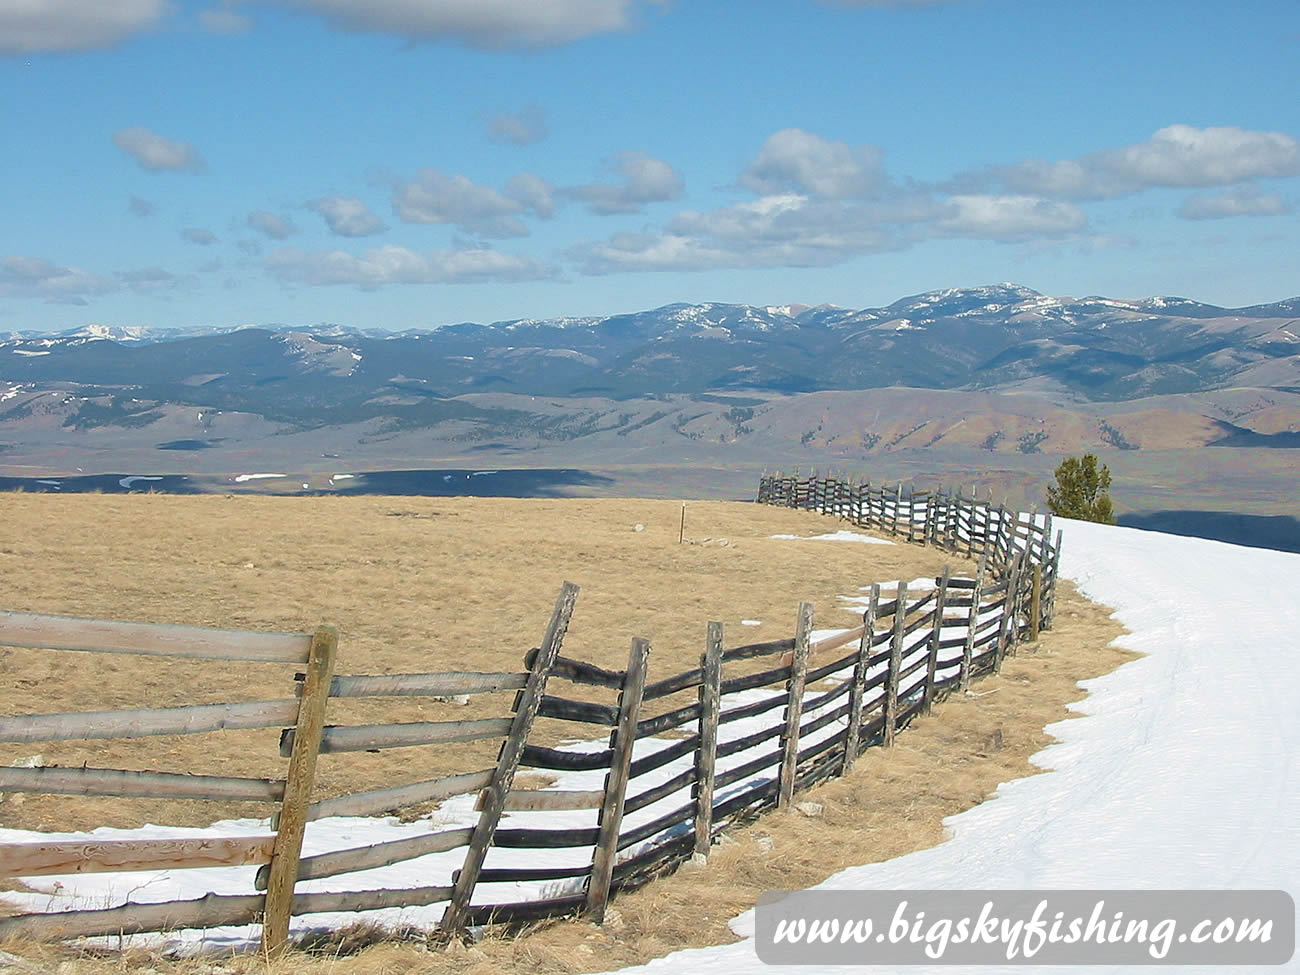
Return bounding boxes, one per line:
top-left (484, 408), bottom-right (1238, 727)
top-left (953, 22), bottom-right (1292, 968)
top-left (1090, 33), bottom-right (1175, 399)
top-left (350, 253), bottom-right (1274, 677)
top-left (0, 494), bottom-right (1125, 975)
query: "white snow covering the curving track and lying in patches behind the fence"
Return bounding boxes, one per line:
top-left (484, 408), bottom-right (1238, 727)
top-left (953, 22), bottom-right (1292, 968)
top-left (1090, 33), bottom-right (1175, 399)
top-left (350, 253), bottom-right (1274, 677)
top-left (0, 520), bottom-right (1300, 975)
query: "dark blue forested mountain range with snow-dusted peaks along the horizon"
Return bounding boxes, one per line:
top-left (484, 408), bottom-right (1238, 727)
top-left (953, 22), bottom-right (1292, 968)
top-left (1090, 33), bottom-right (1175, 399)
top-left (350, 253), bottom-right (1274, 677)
top-left (0, 283), bottom-right (1300, 429)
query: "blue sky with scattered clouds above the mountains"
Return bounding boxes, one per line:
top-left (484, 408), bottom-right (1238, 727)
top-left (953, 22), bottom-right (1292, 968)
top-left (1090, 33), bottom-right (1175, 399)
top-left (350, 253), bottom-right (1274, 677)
top-left (0, 0), bottom-right (1300, 332)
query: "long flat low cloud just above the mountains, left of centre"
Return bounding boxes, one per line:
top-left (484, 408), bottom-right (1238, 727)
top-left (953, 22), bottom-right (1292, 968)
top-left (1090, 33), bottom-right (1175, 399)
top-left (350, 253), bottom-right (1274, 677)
top-left (267, 246), bottom-right (559, 291)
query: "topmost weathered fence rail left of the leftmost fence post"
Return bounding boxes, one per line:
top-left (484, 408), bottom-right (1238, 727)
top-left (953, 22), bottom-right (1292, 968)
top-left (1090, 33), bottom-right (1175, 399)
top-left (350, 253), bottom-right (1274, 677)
top-left (0, 612), bottom-right (312, 663)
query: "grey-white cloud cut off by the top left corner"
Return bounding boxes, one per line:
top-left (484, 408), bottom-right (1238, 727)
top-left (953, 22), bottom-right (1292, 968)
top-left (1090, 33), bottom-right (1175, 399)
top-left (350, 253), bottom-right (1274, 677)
top-left (0, 0), bottom-right (169, 55)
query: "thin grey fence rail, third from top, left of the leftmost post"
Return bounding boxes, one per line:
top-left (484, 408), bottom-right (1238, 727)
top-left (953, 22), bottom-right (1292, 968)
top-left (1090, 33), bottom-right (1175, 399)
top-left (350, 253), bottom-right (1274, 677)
top-left (0, 766), bottom-right (285, 802)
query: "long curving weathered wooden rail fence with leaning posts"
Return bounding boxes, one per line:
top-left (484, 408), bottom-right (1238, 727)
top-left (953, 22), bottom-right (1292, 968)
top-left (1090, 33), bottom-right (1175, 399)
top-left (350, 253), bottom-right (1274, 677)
top-left (0, 476), bottom-right (1061, 950)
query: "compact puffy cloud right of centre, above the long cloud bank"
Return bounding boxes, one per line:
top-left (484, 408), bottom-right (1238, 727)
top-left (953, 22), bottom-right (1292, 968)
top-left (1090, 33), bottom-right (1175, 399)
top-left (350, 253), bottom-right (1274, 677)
top-left (740, 129), bottom-right (884, 200)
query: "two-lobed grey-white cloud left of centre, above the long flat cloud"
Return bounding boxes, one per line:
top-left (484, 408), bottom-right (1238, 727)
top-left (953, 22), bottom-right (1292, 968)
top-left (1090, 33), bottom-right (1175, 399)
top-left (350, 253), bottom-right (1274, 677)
top-left (393, 169), bottom-right (550, 238)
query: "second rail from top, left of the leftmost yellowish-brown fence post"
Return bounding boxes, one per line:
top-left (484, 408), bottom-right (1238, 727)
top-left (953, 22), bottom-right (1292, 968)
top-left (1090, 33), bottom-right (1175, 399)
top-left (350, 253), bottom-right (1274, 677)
top-left (0, 698), bottom-right (298, 741)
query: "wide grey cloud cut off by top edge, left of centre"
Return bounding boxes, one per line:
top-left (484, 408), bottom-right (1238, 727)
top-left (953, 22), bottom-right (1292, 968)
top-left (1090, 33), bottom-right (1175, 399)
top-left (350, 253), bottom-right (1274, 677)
top-left (267, 0), bottom-right (638, 49)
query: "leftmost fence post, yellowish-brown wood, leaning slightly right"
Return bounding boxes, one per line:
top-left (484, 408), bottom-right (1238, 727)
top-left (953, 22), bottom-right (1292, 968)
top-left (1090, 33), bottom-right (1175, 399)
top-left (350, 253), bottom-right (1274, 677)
top-left (261, 627), bottom-right (338, 956)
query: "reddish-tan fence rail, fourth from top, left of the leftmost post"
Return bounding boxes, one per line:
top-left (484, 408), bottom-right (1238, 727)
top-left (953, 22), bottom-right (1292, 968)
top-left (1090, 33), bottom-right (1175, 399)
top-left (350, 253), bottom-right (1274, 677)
top-left (0, 836), bottom-right (276, 876)
